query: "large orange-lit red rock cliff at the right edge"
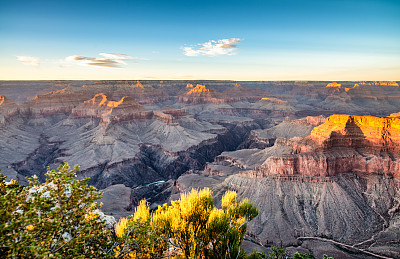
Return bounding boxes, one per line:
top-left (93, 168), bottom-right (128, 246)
top-left (250, 115), bottom-right (400, 178)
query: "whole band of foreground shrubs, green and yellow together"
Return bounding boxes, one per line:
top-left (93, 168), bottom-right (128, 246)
top-left (0, 163), bottom-right (327, 259)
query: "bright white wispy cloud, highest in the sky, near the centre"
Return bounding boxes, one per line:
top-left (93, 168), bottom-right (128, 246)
top-left (182, 38), bottom-right (242, 57)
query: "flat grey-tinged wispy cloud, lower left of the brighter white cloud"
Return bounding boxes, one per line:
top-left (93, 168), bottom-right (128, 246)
top-left (65, 53), bottom-right (141, 68)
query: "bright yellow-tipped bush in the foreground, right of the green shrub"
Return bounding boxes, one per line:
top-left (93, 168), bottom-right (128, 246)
top-left (116, 188), bottom-right (258, 258)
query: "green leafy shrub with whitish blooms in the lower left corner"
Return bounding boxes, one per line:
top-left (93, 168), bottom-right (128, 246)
top-left (0, 163), bottom-right (113, 258)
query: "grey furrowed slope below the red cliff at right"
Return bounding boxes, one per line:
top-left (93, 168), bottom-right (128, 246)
top-left (177, 173), bottom-right (400, 259)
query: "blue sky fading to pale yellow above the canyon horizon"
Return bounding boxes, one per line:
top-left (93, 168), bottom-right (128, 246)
top-left (0, 0), bottom-right (400, 80)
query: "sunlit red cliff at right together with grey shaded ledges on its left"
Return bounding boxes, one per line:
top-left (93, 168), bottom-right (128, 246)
top-left (211, 115), bottom-right (400, 178)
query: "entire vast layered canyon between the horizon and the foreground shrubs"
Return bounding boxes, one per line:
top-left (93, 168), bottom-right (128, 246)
top-left (0, 80), bottom-right (400, 258)
